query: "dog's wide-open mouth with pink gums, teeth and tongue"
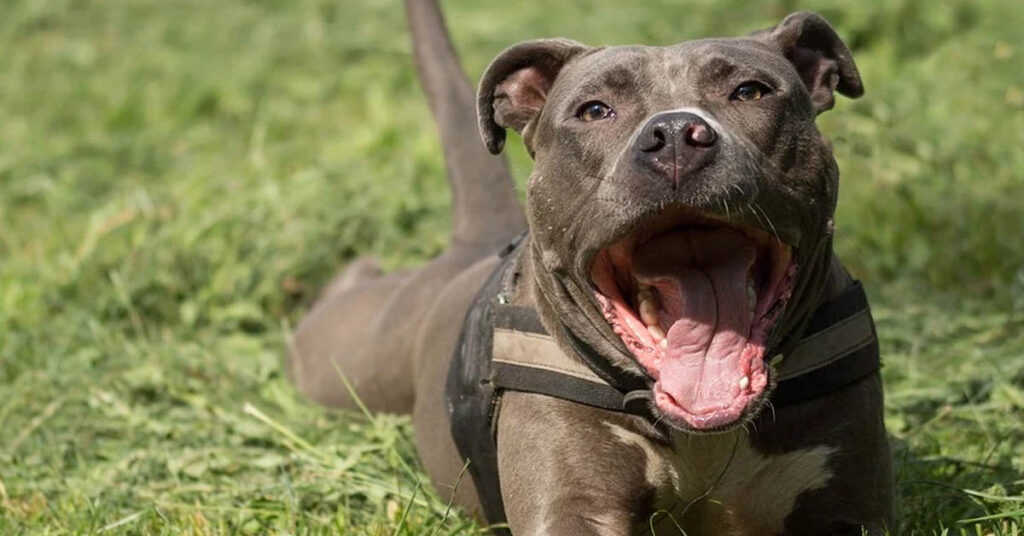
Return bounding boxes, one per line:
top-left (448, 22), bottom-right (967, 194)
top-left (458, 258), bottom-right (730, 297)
top-left (591, 217), bottom-right (796, 431)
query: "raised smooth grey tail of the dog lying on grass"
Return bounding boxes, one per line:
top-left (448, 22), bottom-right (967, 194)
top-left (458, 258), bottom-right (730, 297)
top-left (404, 0), bottom-right (526, 251)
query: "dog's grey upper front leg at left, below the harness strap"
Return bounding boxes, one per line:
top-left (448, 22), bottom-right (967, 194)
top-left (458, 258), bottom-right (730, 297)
top-left (498, 393), bottom-right (656, 536)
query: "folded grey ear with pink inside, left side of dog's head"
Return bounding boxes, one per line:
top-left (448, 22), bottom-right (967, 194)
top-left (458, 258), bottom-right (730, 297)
top-left (476, 39), bottom-right (587, 155)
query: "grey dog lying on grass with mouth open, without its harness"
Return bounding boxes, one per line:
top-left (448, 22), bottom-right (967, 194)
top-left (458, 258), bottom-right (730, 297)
top-left (290, 0), bottom-right (893, 535)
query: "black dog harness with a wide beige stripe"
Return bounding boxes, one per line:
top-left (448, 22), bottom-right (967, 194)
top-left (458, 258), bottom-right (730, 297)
top-left (446, 238), bottom-right (881, 536)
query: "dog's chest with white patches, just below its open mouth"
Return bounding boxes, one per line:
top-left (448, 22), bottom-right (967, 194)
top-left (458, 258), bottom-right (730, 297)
top-left (608, 424), bottom-right (834, 536)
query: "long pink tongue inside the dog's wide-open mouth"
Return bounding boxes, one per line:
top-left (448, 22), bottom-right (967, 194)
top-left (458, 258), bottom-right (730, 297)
top-left (633, 229), bottom-right (757, 415)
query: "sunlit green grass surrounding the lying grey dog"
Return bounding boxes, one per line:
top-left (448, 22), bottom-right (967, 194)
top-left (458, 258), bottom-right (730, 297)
top-left (0, 0), bottom-right (1024, 536)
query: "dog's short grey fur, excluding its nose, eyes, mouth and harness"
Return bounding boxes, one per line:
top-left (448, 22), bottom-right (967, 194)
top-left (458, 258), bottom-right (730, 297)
top-left (290, 0), bottom-right (893, 535)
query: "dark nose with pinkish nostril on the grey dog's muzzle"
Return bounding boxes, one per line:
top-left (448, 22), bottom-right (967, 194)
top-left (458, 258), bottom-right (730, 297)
top-left (636, 112), bottom-right (718, 182)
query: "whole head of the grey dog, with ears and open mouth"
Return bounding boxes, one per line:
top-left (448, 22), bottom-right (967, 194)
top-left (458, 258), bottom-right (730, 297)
top-left (479, 13), bottom-right (862, 430)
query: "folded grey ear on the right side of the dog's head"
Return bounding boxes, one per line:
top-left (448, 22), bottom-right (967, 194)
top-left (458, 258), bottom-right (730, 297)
top-left (751, 11), bottom-right (864, 114)
